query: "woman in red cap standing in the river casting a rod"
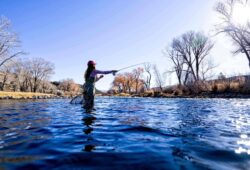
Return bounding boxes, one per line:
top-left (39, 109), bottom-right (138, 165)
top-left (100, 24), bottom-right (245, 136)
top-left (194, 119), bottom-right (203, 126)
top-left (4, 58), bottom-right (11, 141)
top-left (83, 60), bottom-right (117, 112)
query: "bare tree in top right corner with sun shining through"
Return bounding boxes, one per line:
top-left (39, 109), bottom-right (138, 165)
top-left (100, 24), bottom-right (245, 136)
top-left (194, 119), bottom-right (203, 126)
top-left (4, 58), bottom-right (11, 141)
top-left (215, 0), bottom-right (250, 67)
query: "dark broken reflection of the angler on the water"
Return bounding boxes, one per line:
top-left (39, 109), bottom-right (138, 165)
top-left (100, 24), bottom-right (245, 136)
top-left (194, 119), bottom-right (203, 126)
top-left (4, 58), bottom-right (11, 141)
top-left (82, 115), bottom-right (96, 152)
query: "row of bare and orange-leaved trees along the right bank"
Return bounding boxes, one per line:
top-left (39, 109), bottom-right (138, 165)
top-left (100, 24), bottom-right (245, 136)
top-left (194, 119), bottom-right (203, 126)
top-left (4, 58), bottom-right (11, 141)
top-left (112, 0), bottom-right (250, 93)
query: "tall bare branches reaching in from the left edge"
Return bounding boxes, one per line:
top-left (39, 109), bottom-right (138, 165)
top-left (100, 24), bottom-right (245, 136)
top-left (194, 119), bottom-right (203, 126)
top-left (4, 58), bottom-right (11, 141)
top-left (0, 17), bottom-right (23, 67)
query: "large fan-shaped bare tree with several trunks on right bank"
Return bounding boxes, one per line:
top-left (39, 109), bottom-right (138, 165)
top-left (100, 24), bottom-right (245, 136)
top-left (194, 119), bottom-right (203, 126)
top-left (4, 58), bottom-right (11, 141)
top-left (168, 31), bottom-right (214, 82)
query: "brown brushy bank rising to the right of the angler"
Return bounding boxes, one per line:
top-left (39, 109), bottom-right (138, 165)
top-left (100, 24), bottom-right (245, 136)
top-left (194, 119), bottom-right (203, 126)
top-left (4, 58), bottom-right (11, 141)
top-left (104, 75), bottom-right (250, 98)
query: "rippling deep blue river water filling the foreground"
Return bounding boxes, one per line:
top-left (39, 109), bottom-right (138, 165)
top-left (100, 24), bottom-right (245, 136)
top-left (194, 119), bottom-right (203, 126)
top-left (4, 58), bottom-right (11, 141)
top-left (0, 97), bottom-right (250, 170)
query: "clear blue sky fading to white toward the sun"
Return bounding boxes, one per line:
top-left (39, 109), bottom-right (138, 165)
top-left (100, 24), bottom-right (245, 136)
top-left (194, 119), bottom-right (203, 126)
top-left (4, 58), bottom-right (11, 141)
top-left (0, 0), bottom-right (249, 90)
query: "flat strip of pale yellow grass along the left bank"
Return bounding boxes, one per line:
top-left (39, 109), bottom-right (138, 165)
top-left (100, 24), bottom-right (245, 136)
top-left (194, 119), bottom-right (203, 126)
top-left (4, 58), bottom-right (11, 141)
top-left (0, 91), bottom-right (55, 99)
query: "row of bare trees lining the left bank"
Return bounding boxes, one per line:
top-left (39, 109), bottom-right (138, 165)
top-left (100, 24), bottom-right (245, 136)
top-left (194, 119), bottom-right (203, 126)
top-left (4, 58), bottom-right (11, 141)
top-left (0, 17), bottom-right (80, 95)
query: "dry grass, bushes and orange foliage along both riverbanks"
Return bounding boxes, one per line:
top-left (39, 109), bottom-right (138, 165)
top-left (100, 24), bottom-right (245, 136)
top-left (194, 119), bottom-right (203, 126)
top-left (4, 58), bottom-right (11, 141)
top-left (0, 73), bottom-right (250, 99)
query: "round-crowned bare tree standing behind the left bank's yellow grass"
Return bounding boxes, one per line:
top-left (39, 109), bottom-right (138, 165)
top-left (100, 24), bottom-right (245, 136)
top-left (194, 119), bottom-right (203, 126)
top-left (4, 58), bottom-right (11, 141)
top-left (27, 58), bottom-right (54, 92)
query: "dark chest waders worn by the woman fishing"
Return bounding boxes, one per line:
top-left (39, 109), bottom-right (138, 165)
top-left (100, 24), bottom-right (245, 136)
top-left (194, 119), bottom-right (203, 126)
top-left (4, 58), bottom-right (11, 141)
top-left (83, 77), bottom-right (96, 112)
